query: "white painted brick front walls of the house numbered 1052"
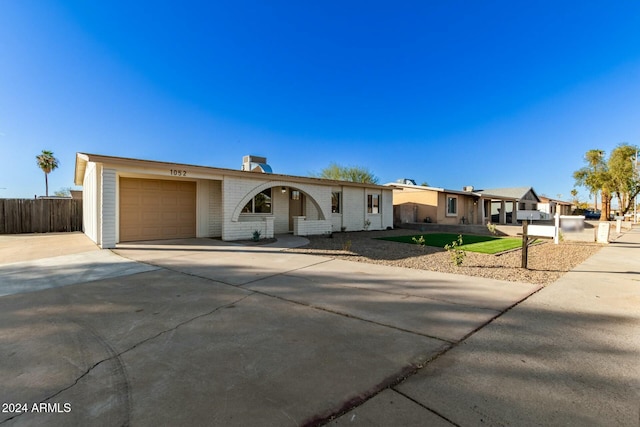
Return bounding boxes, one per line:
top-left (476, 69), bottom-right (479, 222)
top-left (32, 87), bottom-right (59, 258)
top-left (83, 158), bottom-right (393, 244)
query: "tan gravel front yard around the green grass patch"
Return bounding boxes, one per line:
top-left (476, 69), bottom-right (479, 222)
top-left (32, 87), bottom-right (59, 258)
top-left (290, 229), bottom-right (601, 285)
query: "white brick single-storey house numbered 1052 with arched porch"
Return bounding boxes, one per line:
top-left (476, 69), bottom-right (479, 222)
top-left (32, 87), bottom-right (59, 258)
top-left (75, 153), bottom-right (393, 248)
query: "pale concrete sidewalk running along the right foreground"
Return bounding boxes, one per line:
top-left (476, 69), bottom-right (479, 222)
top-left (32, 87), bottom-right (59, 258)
top-left (334, 228), bottom-right (640, 426)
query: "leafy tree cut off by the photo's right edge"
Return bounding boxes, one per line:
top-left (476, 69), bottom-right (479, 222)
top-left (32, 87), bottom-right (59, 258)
top-left (607, 143), bottom-right (640, 215)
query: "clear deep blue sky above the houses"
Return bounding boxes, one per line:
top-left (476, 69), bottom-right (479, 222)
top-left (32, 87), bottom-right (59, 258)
top-left (0, 0), bottom-right (640, 199)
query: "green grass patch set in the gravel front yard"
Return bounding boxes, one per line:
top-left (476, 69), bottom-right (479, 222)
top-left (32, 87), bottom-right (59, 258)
top-left (379, 233), bottom-right (522, 254)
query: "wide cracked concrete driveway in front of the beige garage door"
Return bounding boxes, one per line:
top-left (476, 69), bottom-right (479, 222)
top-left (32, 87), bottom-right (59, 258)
top-left (0, 234), bottom-right (538, 426)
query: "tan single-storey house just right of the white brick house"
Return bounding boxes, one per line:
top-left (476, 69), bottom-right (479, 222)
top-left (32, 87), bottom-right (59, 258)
top-left (385, 179), bottom-right (518, 225)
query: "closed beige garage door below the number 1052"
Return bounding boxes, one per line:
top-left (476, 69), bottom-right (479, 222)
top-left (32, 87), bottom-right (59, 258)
top-left (120, 178), bottom-right (196, 242)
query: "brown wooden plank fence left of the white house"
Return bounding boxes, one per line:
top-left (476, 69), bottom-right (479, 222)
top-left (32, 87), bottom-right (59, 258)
top-left (0, 199), bottom-right (82, 234)
